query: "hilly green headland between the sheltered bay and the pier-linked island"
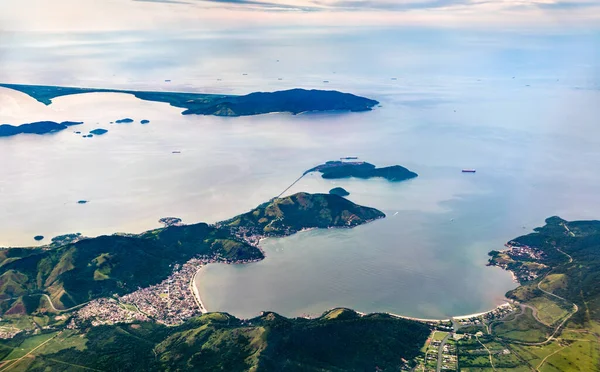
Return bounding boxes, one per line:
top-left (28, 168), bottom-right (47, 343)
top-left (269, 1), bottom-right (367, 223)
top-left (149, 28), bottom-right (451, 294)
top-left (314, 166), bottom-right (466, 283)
top-left (219, 192), bottom-right (385, 236)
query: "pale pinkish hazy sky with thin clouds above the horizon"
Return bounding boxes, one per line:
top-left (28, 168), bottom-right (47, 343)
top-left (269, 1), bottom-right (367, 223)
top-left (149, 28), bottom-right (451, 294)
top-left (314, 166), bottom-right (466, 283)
top-left (0, 0), bottom-right (600, 33)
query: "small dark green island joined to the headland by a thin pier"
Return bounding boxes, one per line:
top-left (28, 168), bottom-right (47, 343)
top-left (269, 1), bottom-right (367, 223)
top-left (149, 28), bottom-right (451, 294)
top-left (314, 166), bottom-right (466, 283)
top-left (304, 161), bottom-right (418, 182)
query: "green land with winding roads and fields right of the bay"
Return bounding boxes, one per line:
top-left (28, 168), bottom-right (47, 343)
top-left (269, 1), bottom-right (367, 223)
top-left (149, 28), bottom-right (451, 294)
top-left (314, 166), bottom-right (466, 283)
top-left (459, 217), bottom-right (600, 372)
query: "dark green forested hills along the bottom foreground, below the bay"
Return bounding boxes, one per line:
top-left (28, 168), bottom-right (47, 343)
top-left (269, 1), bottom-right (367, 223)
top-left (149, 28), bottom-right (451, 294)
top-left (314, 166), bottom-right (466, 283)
top-left (0, 309), bottom-right (429, 371)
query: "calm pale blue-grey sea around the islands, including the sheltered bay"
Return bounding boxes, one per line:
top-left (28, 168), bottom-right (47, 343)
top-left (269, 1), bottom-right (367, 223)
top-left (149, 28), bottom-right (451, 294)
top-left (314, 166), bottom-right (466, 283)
top-left (0, 29), bottom-right (600, 318)
